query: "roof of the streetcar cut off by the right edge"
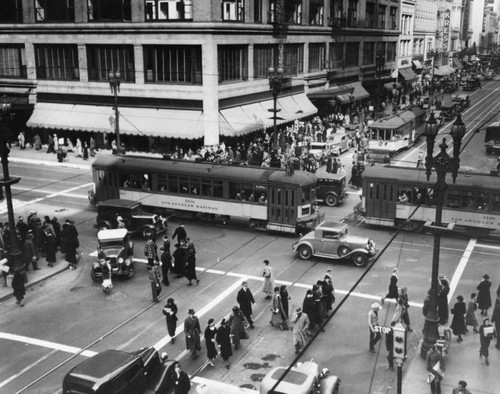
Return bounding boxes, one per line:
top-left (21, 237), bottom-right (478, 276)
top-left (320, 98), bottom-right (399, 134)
top-left (363, 165), bottom-right (500, 190)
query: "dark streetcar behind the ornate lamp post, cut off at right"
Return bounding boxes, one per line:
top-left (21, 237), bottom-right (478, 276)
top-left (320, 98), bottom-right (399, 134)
top-left (361, 166), bottom-right (500, 236)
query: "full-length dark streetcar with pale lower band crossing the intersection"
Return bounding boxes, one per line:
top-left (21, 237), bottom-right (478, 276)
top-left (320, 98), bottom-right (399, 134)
top-left (92, 155), bottom-right (319, 234)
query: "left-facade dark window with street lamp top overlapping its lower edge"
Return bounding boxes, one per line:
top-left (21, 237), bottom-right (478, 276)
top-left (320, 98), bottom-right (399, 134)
top-left (87, 45), bottom-right (135, 82)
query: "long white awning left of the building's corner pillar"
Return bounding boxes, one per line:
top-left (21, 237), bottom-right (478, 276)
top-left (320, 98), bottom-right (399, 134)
top-left (27, 103), bottom-right (203, 139)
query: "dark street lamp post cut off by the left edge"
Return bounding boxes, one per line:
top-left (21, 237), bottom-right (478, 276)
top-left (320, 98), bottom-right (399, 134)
top-left (0, 95), bottom-right (24, 271)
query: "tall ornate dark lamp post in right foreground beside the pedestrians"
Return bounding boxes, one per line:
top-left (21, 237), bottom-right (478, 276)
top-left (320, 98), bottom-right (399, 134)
top-left (420, 112), bottom-right (466, 358)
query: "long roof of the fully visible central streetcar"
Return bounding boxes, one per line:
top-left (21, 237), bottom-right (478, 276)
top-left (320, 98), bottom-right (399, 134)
top-left (92, 154), bottom-right (316, 186)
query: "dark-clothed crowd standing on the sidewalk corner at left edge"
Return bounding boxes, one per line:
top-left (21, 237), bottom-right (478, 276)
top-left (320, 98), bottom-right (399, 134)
top-left (0, 211), bottom-right (80, 306)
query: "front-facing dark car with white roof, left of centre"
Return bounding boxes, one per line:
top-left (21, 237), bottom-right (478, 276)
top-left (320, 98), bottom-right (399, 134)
top-left (90, 228), bottom-right (134, 282)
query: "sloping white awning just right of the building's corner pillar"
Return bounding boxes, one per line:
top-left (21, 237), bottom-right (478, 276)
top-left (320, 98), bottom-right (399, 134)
top-left (219, 93), bottom-right (318, 137)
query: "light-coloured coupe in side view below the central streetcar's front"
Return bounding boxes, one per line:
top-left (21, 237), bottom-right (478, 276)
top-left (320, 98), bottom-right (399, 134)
top-left (292, 221), bottom-right (377, 267)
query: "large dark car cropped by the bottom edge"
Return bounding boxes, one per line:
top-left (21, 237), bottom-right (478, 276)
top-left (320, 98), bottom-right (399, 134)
top-left (62, 347), bottom-right (173, 394)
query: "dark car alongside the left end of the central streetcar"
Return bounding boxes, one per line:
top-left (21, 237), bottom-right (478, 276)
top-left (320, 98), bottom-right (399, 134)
top-left (96, 199), bottom-right (167, 238)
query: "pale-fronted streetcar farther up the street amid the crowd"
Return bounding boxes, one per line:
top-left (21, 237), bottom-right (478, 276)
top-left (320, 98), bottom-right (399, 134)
top-left (368, 106), bottom-right (426, 162)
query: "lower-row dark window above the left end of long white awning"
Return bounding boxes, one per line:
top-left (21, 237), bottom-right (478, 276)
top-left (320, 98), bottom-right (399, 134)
top-left (35, 45), bottom-right (80, 80)
